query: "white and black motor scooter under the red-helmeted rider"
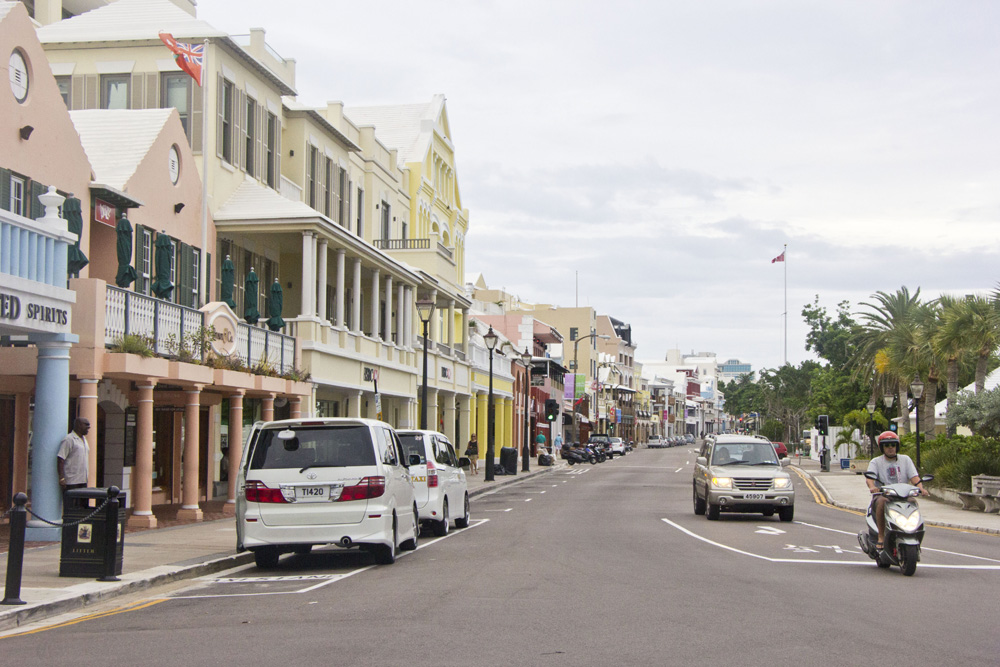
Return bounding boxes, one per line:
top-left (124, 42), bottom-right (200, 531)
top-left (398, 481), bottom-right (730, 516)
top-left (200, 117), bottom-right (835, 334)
top-left (858, 472), bottom-right (934, 577)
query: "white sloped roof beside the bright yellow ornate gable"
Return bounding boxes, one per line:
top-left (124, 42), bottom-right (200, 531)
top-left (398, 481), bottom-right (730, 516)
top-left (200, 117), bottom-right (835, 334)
top-left (344, 94), bottom-right (444, 165)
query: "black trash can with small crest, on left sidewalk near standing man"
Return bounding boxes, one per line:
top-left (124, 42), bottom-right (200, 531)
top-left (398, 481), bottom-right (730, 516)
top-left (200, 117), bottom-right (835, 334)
top-left (59, 489), bottom-right (125, 579)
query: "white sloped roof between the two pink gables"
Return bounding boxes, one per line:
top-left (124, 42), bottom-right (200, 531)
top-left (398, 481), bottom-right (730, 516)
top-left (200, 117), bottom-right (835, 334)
top-left (69, 108), bottom-right (174, 190)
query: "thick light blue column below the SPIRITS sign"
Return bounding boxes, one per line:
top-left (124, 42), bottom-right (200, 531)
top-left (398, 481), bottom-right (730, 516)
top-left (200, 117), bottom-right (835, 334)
top-left (25, 341), bottom-right (72, 542)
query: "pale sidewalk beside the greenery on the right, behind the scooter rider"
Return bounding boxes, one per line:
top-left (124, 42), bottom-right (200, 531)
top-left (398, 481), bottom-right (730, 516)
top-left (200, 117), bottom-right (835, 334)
top-left (789, 456), bottom-right (1000, 535)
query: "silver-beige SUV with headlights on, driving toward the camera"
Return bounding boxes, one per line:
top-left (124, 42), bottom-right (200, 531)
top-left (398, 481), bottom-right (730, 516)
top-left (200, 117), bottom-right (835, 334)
top-left (693, 435), bottom-right (795, 521)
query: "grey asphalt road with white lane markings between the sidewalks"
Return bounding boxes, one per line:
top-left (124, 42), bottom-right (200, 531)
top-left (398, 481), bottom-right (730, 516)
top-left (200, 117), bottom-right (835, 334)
top-left (0, 448), bottom-right (1000, 667)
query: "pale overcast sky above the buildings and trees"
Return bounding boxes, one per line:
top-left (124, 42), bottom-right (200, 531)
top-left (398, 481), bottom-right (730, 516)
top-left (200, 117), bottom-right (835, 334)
top-left (198, 0), bottom-right (1000, 370)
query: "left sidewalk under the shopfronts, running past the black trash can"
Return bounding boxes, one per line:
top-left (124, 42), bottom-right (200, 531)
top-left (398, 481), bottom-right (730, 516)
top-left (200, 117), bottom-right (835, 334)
top-left (0, 460), bottom-right (566, 632)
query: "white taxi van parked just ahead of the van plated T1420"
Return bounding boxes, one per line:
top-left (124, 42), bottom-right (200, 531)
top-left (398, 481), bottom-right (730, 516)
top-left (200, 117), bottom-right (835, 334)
top-left (396, 431), bottom-right (469, 537)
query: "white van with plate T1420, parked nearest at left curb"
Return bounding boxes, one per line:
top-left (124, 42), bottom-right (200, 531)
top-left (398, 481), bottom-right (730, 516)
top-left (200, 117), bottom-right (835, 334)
top-left (236, 419), bottom-right (420, 567)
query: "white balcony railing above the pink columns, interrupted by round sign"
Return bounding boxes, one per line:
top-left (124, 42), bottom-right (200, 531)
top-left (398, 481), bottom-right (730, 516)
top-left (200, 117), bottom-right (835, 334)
top-left (104, 285), bottom-right (295, 375)
